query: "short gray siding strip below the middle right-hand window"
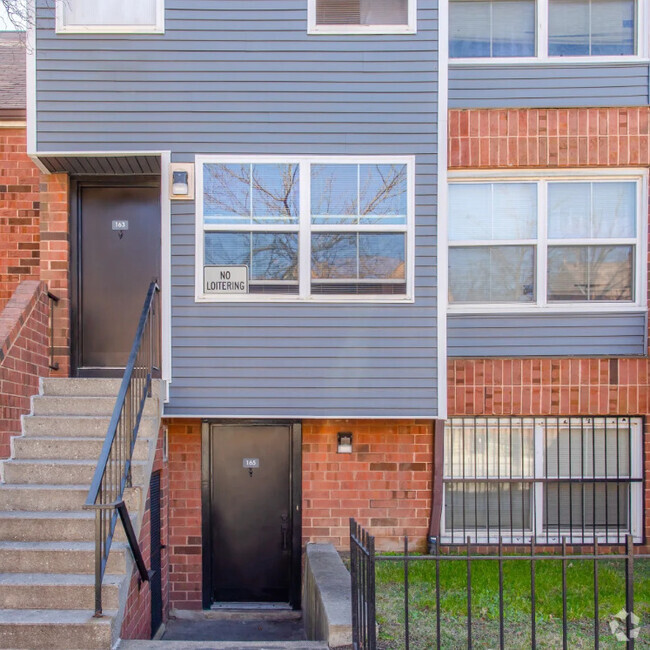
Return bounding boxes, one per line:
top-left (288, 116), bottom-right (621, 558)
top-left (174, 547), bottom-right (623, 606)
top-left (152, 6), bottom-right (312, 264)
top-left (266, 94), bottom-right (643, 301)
top-left (447, 313), bottom-right (647, 357)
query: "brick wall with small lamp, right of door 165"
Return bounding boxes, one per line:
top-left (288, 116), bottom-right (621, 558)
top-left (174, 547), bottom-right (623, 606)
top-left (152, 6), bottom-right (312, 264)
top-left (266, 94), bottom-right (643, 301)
top-left (302, 420), bottom-right (433, 550)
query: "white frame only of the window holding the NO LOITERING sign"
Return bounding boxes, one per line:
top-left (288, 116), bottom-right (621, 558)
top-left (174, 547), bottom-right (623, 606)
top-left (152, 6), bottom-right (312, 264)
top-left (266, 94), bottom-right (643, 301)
top-left (194, 155), bottom-right (415, 304)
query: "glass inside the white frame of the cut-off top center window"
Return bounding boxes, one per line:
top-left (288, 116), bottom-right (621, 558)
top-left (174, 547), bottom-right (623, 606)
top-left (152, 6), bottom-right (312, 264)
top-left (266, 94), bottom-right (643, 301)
top-left (316, 0), bottom-right (408, 25)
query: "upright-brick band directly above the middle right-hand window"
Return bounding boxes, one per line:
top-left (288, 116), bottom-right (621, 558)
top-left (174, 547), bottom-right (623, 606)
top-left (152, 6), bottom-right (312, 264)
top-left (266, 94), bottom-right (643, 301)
top-left (449, 106), bottom-right (650, 169)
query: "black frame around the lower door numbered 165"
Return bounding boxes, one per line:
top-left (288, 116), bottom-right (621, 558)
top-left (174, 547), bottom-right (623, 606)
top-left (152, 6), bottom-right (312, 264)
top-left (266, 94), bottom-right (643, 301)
top-left (201, 419), bottom-right (302, 609)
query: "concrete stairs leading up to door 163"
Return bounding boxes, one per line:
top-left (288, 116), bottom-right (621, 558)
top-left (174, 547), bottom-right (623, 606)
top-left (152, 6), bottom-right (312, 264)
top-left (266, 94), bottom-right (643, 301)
top-left (0, 379), bottom-right (160, 650)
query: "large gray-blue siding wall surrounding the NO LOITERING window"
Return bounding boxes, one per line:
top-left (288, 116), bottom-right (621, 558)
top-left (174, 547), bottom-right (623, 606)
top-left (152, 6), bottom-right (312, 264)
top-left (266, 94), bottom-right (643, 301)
top-left (37, 0), bottom-right (438, 418)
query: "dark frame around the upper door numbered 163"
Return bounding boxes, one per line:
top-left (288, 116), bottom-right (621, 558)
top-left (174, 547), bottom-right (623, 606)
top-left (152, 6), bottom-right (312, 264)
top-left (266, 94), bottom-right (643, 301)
top-left (70, 175), bottom-right (162, 377)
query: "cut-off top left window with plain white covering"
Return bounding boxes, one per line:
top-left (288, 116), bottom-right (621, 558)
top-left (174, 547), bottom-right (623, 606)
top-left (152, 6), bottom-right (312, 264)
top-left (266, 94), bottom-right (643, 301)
top-left (56, 0), bottom-right (165, 34)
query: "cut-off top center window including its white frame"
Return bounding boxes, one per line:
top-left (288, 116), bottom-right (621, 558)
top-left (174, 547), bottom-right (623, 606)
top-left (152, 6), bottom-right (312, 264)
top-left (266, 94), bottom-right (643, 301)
top-left (309, 0), bottom-right (416, 34)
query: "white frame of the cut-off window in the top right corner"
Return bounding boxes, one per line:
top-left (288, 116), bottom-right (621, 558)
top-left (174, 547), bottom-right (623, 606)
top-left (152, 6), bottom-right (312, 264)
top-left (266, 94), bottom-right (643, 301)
top-left (447, 0), bottom-right (650, 66)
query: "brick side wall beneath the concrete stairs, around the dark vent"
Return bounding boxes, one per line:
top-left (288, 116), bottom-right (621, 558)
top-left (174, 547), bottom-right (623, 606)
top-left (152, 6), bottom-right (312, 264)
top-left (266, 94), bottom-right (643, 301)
top-left (117, 430), bottom-right (169, 639)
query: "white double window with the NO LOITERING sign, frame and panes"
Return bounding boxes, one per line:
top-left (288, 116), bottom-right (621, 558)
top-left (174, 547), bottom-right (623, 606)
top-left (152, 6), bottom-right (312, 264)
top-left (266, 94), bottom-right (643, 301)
top-left (196, 156), bottom-right (414, 301)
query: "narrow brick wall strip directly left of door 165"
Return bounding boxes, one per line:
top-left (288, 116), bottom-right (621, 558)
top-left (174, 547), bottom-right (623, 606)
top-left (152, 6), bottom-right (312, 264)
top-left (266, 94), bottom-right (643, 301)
top-left (167, 420), bottom-right (203, 609)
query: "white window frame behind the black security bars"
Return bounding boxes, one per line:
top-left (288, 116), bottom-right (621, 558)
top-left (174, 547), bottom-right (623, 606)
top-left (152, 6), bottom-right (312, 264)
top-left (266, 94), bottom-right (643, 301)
top-left (440, 416), bottom-right (644, 545)
